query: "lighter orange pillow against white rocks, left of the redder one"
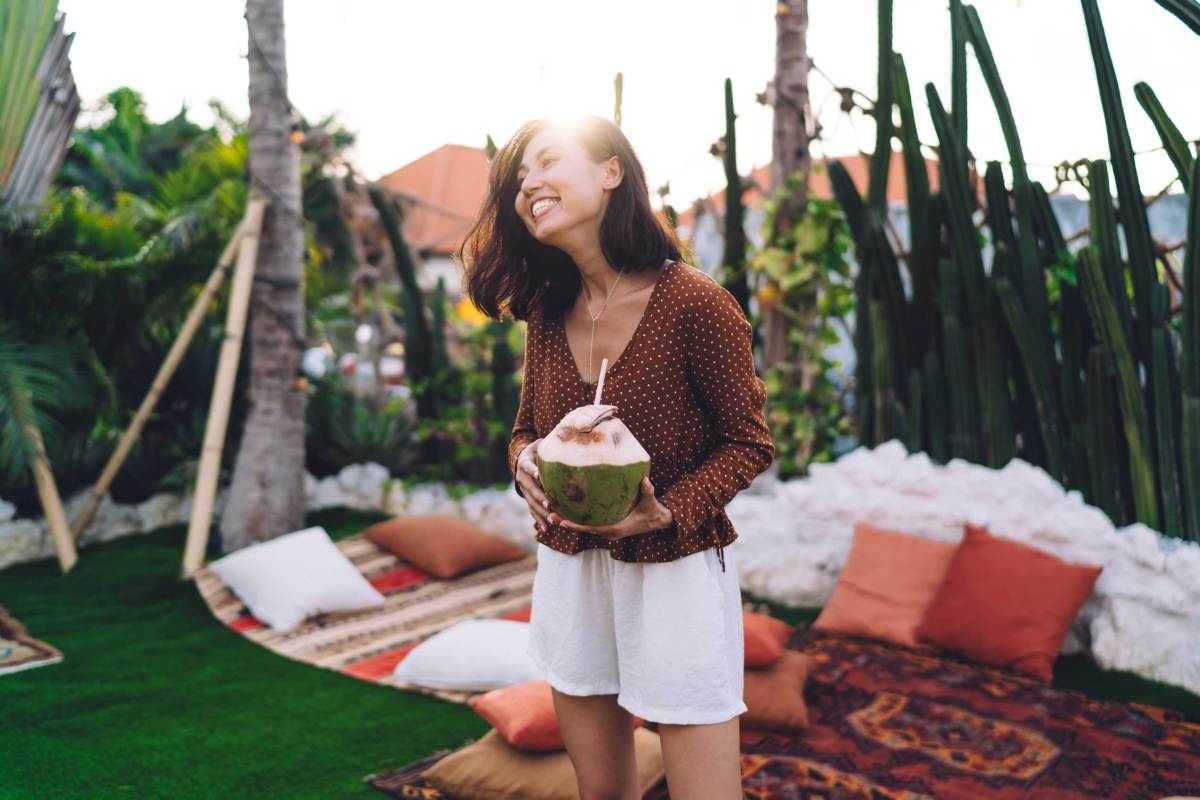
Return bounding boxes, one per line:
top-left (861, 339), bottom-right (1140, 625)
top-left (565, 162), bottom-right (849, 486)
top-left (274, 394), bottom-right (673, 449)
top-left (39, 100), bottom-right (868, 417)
top-left (812, 522), bottom-right (958, 648)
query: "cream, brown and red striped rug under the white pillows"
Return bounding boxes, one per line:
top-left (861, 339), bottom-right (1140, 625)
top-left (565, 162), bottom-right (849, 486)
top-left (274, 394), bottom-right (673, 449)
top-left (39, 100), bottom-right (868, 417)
top-left (196, 534), bottom-right (538, 703)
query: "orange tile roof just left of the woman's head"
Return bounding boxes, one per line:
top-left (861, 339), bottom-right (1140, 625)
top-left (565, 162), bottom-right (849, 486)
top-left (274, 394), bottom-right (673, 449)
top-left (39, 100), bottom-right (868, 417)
top-left (378, 144), bottom-right (488, 255)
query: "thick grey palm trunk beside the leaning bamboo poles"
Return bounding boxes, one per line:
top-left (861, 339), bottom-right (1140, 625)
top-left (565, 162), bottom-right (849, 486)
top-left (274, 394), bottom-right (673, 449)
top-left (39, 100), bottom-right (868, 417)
top-left (221, 0), bottom-right (305, 553)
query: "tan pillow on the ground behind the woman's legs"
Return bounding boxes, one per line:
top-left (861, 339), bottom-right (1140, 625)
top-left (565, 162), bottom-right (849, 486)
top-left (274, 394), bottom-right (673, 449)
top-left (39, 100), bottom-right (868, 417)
top-left (421, 728), bottom-right (664, 800)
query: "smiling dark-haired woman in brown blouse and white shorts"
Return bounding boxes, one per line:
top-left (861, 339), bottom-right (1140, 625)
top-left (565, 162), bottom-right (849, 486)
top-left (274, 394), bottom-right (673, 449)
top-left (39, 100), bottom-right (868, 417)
top-left (458, 116), bottom-right (774, 800)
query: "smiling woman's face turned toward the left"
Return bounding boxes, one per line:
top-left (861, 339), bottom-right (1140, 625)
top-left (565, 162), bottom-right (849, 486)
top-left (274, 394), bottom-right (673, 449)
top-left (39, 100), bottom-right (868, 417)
top-left (516, 128), bottom-right (622, 252)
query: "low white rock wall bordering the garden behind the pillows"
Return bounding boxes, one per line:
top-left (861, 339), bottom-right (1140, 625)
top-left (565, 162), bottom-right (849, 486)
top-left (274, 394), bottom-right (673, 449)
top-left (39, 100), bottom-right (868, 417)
top-left (0, 441), bottom-right (1200, 693)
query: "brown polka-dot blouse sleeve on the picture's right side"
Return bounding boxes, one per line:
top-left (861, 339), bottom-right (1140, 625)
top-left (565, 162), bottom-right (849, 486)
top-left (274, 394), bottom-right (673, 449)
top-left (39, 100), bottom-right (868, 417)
top-left (659, 284), bottom-right (775, 541)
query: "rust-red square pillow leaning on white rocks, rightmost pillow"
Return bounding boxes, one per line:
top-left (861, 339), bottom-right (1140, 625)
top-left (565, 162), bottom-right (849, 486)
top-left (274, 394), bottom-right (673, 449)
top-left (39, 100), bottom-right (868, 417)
top-left (917, 525), bottom-right (1104, 681)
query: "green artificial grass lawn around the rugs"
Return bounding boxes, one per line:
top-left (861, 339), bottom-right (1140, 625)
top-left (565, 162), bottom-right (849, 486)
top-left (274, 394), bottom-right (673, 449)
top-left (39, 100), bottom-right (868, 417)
top-left (0, 509), bottom-right (1200, 800)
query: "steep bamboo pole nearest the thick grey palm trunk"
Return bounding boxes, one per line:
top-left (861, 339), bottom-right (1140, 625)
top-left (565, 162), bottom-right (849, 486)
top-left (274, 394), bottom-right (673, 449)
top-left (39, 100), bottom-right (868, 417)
top-left (181, 194), bottom-right (266, 579)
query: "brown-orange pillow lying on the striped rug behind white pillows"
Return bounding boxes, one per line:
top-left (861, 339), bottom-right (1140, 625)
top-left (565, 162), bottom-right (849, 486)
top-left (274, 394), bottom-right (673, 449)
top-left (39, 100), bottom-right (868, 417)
top-left (362, 515), bottom-right (528, 581)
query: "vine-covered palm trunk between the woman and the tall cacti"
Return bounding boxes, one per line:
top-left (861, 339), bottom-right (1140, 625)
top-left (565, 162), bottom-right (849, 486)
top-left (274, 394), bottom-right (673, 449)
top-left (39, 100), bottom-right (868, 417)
top-left (763, 0), bottom-right (812, 367)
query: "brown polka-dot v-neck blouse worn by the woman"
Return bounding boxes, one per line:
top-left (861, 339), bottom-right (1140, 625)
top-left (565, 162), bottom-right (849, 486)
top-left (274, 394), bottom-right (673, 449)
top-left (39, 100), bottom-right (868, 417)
top-left (509, 261), bottom-right (775, 570)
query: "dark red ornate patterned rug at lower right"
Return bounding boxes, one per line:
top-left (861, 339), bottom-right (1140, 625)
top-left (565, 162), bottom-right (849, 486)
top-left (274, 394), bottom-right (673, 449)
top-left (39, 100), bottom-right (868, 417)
top-left (364, 628), bottom-right (1200, 800)
